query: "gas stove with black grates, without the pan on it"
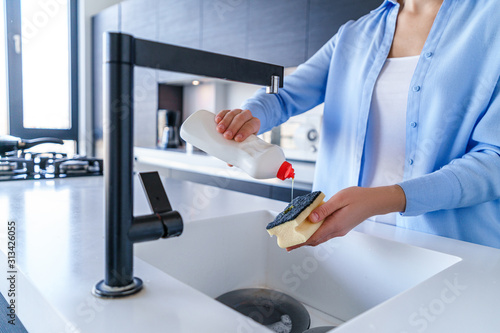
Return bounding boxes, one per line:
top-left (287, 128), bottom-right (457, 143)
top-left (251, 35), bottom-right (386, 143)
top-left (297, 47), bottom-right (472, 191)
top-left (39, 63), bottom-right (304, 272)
top-left (0, 152), bottom-right (103, 181)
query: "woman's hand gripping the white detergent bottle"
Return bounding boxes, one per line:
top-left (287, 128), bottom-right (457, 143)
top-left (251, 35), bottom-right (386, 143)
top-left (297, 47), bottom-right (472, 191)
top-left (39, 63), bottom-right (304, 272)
top-left (215, 109), bottom-right (260, 142)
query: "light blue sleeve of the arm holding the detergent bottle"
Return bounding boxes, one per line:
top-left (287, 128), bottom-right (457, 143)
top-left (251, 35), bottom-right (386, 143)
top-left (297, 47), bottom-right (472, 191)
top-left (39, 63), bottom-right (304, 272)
top-left (241, 26), bottom-right (340, 134)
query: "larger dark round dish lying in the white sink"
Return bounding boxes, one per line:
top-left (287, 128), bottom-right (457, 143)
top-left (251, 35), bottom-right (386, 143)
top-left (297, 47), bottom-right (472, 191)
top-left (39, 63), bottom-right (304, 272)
top-left (216, 288), bottom-right (311, 333)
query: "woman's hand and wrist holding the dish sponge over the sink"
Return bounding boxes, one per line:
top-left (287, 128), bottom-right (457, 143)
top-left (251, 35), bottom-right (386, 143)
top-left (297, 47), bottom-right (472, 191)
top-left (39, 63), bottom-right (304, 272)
top-left (287, 185), bottom-right (406, 251)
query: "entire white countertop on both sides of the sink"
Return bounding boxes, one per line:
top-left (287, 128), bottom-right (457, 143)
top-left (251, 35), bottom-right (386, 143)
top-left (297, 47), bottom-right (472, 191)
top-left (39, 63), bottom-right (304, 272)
top-left (0, 177), bottom-right (500, 333)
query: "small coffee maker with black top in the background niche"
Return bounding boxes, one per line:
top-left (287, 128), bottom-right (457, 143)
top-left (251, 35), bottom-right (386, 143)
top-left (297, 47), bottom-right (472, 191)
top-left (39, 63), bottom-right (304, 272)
top-left (157, 109), bottom-right (181, 149)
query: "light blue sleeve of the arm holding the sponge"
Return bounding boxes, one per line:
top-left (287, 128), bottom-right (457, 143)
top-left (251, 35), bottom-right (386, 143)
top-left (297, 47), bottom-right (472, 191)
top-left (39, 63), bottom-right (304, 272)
top-left (398, 76), bottom-right (500, 216)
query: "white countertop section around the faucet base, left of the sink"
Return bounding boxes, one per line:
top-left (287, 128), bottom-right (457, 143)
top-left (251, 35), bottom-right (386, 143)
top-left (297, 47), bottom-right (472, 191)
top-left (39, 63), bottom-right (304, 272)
top-left (0, 177), bottom-right (284, 333)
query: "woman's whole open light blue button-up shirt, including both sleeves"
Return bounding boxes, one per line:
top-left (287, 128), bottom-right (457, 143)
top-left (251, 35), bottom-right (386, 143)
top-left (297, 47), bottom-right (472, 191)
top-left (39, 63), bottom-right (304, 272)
top-left (243, 0), bottom-right (500, 248)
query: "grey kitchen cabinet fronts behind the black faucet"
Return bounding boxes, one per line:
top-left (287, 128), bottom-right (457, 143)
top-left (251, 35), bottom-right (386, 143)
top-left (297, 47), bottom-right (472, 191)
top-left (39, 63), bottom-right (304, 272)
top-left (92, 0), bottom-right (382, 156)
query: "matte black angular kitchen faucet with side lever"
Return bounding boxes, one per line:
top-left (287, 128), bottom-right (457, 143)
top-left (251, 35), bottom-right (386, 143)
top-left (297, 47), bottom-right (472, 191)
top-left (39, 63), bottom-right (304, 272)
top-left (93, 32), bottom-right (284, 298)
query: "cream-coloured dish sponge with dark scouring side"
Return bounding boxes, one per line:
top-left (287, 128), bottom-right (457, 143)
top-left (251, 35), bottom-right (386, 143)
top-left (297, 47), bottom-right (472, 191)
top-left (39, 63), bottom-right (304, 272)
top-left (266, 191), bottom-right (325, 248)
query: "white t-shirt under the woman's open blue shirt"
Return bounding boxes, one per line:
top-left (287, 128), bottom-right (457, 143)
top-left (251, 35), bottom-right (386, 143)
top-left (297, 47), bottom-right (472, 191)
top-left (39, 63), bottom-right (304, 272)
top-left (362, 56), bottom-right (419, 224)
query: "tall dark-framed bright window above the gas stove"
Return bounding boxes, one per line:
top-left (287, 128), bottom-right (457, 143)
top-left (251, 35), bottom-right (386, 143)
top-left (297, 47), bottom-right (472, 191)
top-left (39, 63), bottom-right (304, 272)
top-left (0, 0), bottom-right (78, 152)
